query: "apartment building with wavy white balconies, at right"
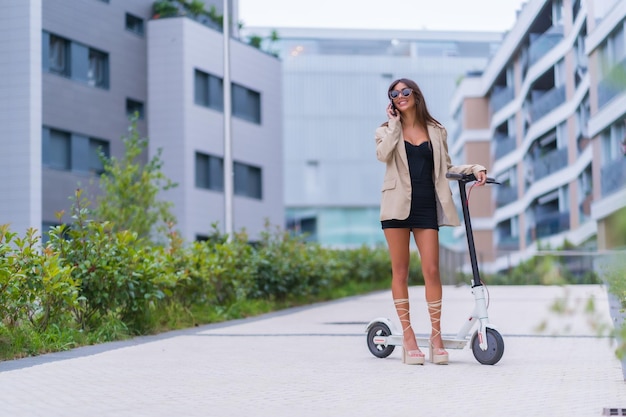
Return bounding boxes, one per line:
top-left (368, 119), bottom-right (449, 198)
top-left (449, 0), bottom-right (626, 270)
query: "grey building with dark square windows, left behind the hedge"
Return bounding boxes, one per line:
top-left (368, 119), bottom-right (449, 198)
top-left (0, 0), bottom-right (284, 241)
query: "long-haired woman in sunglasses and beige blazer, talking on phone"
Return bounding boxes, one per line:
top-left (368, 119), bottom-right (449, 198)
top-left (376, 78), bottom-right (487, 365)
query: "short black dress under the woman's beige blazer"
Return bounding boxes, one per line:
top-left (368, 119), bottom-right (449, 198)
top-left (381, 141), bottom-right (439, 230)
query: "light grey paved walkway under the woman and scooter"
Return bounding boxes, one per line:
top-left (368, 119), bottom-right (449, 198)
top-left (0, 286), bottom-right (626, 417)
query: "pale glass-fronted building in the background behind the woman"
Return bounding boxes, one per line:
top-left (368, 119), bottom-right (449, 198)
top-left (241, 28), bottom-right (502, 247)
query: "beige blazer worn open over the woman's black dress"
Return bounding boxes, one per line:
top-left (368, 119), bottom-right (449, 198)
top-left (376, 119), bottom-right (486, 226)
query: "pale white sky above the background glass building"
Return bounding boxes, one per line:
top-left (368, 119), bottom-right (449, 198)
top-left (239, 0), bottom-right (526, 32)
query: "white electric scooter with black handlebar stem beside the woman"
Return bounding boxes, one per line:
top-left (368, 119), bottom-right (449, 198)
top-left (366, 173), bottom-right (504, 365)
